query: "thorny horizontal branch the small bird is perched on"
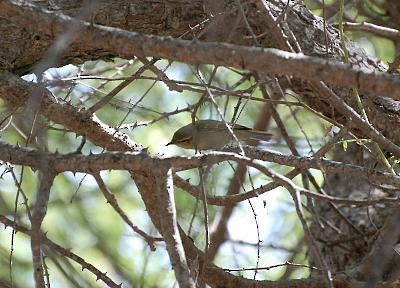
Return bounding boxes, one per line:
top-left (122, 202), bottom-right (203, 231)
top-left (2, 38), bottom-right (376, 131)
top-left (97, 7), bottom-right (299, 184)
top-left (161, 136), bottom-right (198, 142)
top-left (0, 142), bottom-right (400, 187)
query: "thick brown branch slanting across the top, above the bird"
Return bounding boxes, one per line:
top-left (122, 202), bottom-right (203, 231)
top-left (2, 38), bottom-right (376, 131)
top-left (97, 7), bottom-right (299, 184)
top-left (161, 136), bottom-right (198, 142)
top-left (0, 1), bottom-right (400, 100)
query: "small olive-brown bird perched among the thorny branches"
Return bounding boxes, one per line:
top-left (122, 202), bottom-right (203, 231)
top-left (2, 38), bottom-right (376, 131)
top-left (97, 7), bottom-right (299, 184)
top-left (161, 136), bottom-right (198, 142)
top-left (167, 120), bottom-right (272, 150)
